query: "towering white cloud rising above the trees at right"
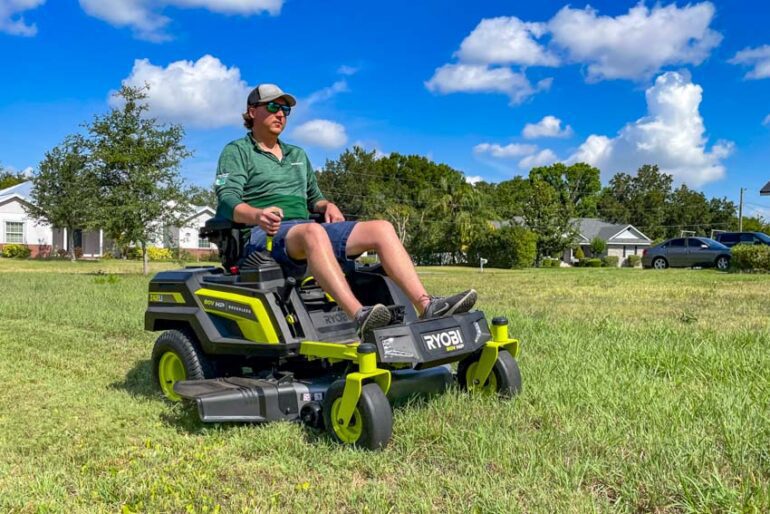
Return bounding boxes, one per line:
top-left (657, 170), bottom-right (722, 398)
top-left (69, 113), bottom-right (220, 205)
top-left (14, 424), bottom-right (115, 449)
top-left (567, 72), bottom-right (734, 187)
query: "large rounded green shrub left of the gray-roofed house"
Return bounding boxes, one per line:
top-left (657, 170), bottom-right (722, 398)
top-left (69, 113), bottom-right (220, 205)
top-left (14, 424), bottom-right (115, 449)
top-left (467, 226), bottom-right (537, 269)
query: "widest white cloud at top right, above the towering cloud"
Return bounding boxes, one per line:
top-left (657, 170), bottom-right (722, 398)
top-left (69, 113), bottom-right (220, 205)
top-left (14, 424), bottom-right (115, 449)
top-left (548, 2), bottom-right (722, 80)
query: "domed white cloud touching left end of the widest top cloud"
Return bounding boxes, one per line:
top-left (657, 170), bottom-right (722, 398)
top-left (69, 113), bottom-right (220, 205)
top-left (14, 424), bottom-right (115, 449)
top-left (457, 16), bottom-right (559, 66)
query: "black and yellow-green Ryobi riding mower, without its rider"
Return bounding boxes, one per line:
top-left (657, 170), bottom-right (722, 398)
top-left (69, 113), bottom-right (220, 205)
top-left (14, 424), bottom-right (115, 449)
top-left (145, 218), bottom-right (521, 449)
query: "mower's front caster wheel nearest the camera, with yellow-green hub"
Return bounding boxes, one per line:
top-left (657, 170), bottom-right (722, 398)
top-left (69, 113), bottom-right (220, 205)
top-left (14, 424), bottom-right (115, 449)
top-left (323, 380), bottom-right (393, 450)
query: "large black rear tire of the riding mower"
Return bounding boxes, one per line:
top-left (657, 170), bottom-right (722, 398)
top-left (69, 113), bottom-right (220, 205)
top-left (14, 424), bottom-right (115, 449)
top-left (152, 330), bottom-right (216, 401)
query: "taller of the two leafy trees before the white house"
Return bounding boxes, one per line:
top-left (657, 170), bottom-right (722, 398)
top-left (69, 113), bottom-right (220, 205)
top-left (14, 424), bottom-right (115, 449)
top-left (88, 86), bottom-right (191, 275)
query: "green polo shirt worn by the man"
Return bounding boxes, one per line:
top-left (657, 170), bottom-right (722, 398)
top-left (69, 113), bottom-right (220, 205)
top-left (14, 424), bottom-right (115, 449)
top-left (215, 134), bottom-right (324, 220)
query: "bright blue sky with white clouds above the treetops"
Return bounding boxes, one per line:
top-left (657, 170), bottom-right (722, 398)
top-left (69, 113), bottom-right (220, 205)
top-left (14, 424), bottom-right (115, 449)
top-left (0, 0), bottom-right (770, 218)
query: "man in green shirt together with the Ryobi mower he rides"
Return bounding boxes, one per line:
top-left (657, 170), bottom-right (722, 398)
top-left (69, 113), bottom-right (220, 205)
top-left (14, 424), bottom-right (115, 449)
top-left (145, 84), bottom-right (520, 449)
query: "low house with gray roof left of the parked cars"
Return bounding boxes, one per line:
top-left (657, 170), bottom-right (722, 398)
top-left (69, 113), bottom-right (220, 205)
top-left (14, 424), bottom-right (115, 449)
top-left (562, 218), bottom-right (652, 266)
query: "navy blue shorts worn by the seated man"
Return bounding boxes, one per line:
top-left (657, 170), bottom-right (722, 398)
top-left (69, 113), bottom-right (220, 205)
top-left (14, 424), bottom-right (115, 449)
top-left (243, 220), bottom-right (358, 276)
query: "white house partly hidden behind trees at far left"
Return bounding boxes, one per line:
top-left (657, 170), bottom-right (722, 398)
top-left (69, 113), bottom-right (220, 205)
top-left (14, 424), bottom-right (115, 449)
top-left (0, 181), bottom-right (216, 257)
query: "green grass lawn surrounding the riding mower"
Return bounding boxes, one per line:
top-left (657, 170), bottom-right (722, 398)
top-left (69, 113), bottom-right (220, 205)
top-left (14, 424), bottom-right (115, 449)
top-left (0, 259), bottom-right (770, 513)
